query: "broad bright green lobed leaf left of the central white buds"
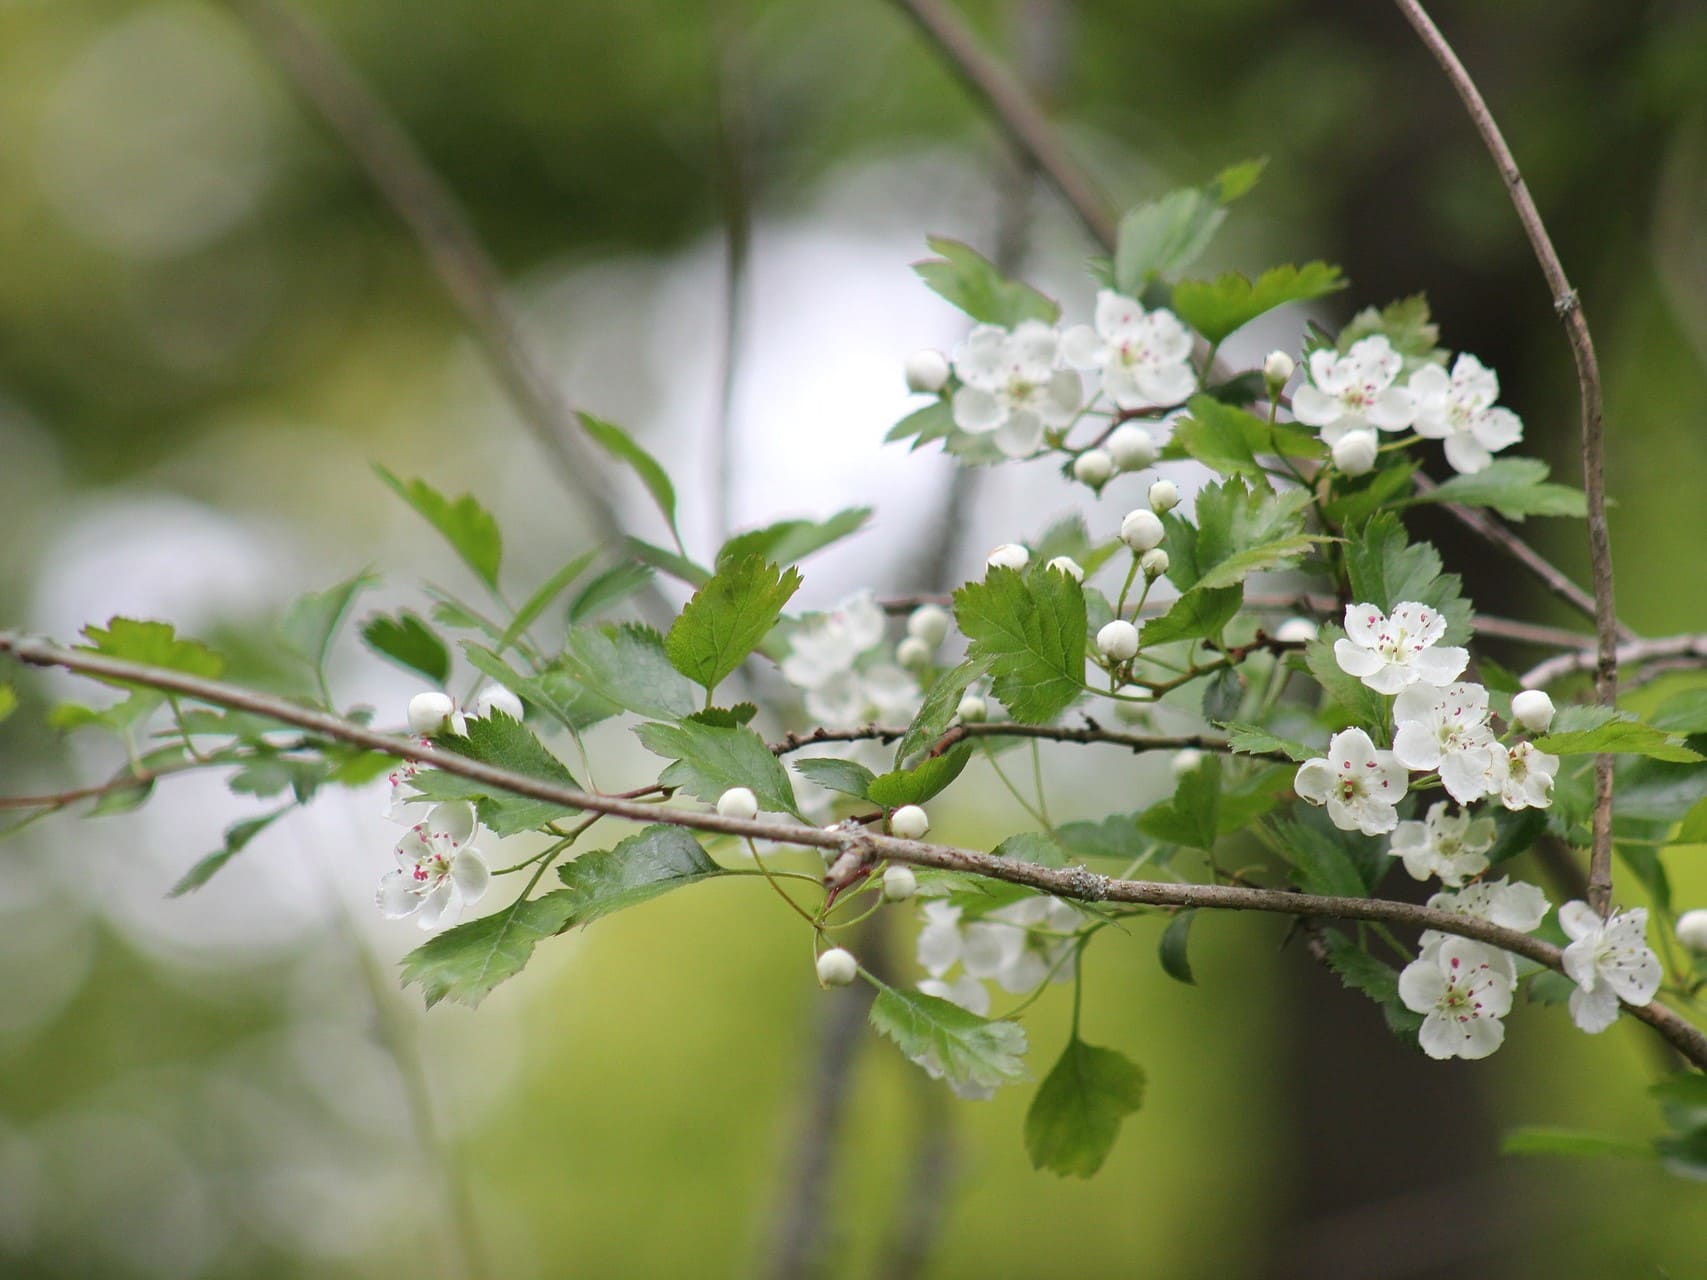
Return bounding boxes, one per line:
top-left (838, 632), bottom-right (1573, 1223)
top-left (954, 568), bottom-right (1086, 724)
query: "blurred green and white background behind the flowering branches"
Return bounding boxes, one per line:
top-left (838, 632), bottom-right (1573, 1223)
top-left (0, 0), bottom-right (1707, 1280)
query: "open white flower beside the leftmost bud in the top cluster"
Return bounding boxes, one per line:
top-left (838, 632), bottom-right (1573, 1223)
top-left (954, 321), bottom-right (1082, 457)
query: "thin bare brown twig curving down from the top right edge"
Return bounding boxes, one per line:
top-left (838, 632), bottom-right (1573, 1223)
top-left (1393, 0), bottom-right (1618, 916)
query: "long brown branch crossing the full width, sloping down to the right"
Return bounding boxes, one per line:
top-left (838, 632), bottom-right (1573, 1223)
top-left (0, 631), bottom-right (1707, 1070)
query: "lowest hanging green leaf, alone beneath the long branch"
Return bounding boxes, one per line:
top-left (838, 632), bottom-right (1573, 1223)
top-left (1026, 1036), bottom-right (1144, 1178)
